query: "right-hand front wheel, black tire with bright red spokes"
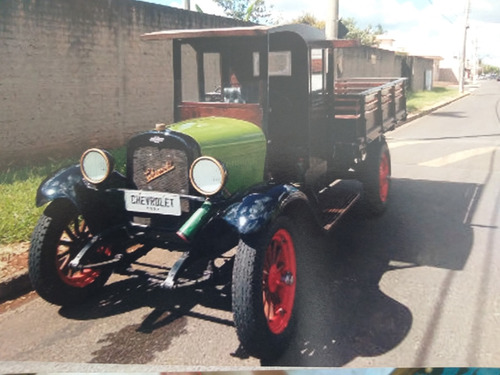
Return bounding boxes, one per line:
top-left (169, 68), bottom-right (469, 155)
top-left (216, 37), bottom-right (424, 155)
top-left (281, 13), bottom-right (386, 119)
top-left (232, 216), bottom-right (300, 360)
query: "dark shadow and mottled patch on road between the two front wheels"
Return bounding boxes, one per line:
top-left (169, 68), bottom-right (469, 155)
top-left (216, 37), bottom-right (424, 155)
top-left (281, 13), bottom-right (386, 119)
top-left (59, 264), bottom-right (237, 364)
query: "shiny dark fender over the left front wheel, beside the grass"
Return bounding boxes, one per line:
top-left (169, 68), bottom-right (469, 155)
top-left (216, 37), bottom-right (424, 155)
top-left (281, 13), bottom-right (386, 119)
top-left (36, 164), bottom-right (127, 233)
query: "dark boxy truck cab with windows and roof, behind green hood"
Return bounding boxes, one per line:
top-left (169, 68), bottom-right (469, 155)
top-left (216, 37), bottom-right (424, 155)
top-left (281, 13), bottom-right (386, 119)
top-left (143, 25), bottom-right (334, 187)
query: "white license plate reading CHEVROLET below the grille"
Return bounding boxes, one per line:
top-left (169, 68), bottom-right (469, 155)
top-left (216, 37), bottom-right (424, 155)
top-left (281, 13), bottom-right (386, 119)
top-left (125, 190), bottom-right (181, 216)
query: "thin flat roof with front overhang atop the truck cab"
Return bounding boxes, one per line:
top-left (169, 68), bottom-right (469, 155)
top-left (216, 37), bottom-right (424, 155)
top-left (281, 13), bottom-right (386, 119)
top-left (141, 24), bottom-right (326, 44)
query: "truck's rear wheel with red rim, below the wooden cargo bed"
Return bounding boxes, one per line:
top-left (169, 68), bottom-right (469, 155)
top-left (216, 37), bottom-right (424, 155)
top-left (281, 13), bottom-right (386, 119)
top-left (361, 140), bottom-right (391, 217)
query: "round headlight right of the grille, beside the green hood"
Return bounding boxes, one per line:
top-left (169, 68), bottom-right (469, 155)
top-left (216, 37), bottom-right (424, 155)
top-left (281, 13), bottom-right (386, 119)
top-left (189, 156), bottom-right (227, 195)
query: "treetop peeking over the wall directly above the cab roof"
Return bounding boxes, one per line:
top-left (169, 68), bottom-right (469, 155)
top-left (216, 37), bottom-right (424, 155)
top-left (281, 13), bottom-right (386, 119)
top-left (213, 0), bottom-right (272, 23)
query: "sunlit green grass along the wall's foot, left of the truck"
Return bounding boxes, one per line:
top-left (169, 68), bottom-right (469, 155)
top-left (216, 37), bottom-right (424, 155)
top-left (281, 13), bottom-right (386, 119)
top-left (0, 148), bottom-right (126, 245)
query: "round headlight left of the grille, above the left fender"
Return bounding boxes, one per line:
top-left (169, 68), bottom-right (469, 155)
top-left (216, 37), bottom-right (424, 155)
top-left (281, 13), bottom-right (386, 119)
top-left (80, 148), bottom-right (114, 184)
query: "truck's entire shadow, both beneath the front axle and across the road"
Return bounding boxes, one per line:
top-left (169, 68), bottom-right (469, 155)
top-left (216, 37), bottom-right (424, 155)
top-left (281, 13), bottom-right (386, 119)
top-left (59, 179), bottom-right (481, 367)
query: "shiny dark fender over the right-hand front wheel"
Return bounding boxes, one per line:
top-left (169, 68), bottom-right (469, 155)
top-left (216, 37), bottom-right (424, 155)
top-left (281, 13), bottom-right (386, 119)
top-left (222, 184), bottom-right (312, 235)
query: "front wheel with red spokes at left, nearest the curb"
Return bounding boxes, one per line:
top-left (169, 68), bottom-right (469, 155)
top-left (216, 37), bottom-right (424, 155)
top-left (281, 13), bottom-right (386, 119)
top-left (28, 200), bottom-right (112, 306)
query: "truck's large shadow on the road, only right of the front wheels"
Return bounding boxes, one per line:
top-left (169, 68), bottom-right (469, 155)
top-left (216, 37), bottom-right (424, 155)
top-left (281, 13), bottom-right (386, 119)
top-left (268, 179), bottom-right (481, 367)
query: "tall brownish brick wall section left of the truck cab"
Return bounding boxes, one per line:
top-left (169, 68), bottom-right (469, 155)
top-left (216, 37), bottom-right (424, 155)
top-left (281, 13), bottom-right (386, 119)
top-left (0, 0), bottom-right (248, 169)
